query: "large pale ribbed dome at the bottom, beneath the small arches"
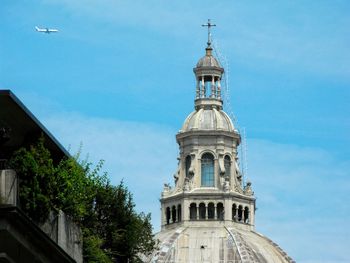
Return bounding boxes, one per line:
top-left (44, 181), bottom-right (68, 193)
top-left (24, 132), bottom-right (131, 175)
top-left (151, 225), bottom-right (295, 263)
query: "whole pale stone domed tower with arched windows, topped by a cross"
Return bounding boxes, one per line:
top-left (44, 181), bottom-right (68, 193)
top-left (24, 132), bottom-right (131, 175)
top-left (150, 20), bottom-right (293, 263)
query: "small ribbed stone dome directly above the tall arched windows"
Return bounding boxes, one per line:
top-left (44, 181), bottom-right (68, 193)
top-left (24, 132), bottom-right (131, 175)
top-left (180, 108), bottom-right (234, 132)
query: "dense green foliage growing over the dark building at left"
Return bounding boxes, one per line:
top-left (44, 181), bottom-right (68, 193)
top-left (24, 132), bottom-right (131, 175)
top-left (10, 137), bottom-right (155, 263)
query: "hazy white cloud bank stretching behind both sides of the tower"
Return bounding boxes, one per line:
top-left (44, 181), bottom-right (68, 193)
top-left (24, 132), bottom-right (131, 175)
top-left (40, 114), bottom-right (350, 263)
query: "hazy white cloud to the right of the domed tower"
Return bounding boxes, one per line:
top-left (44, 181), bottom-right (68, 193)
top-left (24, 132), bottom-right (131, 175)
top-left (248, 139), bottom-right (350, 262)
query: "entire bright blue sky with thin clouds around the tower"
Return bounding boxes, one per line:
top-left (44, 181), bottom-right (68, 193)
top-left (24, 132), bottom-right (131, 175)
top-left (0, 0), bottom-right (350, 263)
